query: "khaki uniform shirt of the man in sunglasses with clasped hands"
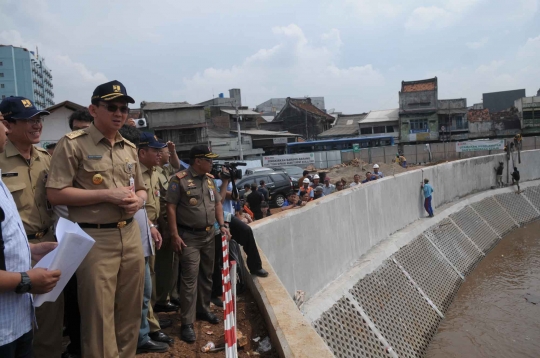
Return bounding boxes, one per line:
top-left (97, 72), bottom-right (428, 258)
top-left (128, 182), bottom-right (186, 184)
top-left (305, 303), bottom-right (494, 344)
top-left (47, 124), bottom-right (146, 224)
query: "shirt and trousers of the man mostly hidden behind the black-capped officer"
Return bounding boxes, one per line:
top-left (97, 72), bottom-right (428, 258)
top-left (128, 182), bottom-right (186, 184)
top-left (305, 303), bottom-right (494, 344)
top-left (155, 165), bottom-right (179, 306)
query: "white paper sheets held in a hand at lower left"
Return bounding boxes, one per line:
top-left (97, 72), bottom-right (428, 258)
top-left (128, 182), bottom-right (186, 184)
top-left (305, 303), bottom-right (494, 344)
top-left (34, 218), bottom-right (95, 307)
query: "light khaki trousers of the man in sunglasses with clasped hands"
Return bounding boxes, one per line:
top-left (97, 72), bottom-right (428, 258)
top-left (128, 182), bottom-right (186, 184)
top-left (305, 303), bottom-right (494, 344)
top-left (77, 222), bottom-right (144, 358)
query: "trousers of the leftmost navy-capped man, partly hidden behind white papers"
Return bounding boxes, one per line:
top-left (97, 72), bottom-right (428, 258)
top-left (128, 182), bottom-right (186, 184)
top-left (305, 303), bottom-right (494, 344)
top-left (30, 229), bottom-right (64, 358)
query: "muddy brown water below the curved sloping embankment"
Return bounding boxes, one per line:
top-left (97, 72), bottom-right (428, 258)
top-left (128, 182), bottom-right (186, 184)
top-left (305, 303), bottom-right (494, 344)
top-left (426, 221), bottom-right (540, 358)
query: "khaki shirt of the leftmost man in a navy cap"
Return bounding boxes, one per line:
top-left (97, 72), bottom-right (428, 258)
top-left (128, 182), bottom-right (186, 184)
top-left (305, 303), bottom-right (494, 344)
top-left (0, 140), bottom-right (54, 235)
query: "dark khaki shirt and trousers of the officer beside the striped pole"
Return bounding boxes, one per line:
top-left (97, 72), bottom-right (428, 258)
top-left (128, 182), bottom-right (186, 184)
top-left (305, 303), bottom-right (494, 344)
top-left (166, 153), bottom-right (221, 326)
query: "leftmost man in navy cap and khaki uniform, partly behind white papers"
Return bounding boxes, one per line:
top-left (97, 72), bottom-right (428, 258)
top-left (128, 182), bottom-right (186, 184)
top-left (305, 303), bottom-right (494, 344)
top-left (0, 97), bottom-right (64, 358)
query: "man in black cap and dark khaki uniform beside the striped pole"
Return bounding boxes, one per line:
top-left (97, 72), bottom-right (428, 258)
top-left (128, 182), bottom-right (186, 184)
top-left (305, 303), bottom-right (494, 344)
top-left (166, 145), bottom-right (230, 343)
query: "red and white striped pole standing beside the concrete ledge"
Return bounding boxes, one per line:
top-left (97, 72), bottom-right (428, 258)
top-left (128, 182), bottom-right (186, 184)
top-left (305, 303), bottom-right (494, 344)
top-left (221, 235), bottom-right (238, 358)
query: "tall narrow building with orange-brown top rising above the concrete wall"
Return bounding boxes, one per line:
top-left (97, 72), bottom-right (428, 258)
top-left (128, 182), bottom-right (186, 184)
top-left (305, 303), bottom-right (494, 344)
top-left (399, 77), bottom-right (439, 143)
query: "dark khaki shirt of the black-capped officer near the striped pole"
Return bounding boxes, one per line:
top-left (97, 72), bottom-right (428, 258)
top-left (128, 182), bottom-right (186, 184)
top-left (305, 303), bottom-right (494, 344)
top-left (166, 167), bottom-right (221, 229)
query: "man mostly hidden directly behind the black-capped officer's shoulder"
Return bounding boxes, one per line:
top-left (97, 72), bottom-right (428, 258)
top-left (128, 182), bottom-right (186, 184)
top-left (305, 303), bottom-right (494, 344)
top-left (155, 142), bottom-right (180, 310)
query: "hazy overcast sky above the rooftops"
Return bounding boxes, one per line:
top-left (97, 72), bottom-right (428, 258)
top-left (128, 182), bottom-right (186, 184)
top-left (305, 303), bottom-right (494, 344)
top-left (0, 0), bottom-right (540, 113)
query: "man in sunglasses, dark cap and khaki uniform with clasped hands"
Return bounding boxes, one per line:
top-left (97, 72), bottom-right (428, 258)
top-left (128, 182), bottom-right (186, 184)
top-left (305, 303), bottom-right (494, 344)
top-left (47, 81), bottom-right (147, 358)
